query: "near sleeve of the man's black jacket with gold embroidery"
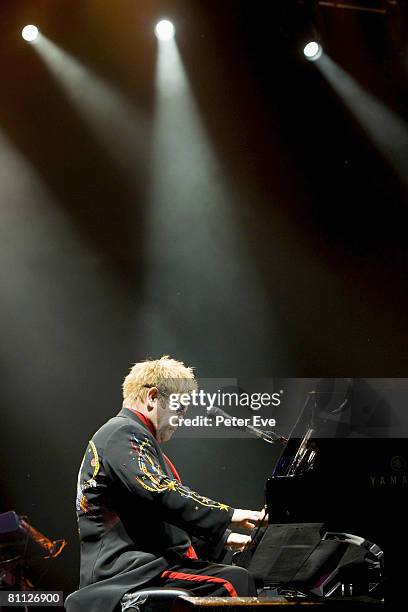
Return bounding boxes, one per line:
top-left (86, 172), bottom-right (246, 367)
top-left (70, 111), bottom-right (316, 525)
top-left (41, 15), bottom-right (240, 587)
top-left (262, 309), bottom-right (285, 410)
top-left (103, 424), bottom-right (234, 544)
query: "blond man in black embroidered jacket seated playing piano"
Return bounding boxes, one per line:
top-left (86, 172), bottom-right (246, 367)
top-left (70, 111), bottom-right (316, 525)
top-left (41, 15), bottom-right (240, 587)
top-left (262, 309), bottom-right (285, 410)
top-left (67, 356), bottom-right (261, 612)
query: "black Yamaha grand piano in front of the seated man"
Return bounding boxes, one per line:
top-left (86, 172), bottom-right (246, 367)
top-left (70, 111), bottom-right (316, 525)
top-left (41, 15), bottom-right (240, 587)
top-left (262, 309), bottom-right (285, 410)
top-left (235, 382), bottom-right (406, 602)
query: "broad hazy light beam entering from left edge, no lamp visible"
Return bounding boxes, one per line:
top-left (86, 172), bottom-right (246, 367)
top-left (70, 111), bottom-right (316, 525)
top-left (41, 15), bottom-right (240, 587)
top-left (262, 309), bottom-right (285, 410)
top-left (0, 131), bottom-right (131, 426)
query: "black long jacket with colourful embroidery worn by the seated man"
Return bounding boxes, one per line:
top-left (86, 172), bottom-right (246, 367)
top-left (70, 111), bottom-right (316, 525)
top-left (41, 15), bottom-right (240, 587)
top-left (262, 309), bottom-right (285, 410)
top-left (66, 408), bottom-right (233, 612)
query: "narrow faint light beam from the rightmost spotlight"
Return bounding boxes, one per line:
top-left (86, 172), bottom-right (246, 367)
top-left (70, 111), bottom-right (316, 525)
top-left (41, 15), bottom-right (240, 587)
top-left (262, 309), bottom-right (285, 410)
top-left (317, 54), bottom-right (408, 185)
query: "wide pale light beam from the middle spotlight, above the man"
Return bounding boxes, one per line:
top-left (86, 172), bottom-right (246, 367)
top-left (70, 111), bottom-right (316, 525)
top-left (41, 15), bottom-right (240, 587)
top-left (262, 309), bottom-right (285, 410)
top-left (143, 39), bottom-right (273, 367)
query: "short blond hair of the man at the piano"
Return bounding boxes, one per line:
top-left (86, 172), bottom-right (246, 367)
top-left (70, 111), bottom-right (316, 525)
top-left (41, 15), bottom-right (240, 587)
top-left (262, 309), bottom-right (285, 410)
top-left (122, 355), bottom-right (197, 406)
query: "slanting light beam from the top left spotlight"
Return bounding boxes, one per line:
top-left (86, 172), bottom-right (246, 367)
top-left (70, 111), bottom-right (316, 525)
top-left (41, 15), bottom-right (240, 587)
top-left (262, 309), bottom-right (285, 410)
top-left (31, 35), bottom-right (149, 177)
